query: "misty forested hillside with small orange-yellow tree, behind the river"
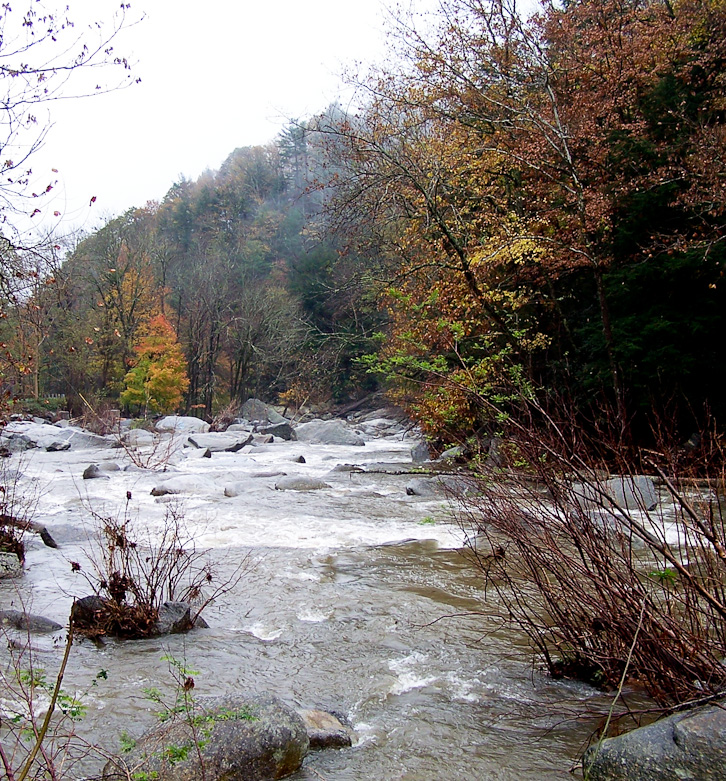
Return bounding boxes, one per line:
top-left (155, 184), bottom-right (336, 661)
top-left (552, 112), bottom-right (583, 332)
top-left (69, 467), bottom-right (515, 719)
top-left (3, 125), bottom-right (376, 416)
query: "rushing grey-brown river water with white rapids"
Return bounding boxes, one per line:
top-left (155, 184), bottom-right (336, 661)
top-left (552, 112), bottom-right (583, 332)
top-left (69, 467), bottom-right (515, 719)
top-left (0, 420), bottom-right (620, 781)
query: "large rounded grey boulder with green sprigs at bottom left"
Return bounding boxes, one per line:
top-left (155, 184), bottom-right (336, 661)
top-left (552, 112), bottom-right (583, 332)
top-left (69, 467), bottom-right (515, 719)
top-left (103, 694), bottom-right (309, 781)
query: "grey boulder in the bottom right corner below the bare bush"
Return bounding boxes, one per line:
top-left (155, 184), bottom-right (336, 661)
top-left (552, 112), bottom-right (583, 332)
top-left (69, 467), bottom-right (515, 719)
top-left (583, 705), bottom-right (726, 781)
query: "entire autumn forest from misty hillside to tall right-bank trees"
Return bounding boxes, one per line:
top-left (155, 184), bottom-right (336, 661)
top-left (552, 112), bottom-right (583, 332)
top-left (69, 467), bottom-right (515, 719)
top-left (0, 0), bottom-right (726, 445)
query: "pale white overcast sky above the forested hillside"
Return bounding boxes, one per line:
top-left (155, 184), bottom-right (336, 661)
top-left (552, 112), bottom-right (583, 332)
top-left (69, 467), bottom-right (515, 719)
top-left (19, 0), bottom-right (431, 238)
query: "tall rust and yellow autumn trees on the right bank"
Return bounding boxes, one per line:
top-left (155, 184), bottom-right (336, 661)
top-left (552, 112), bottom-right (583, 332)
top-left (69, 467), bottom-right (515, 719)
top-left (323, 0), bottom-right (726, 441)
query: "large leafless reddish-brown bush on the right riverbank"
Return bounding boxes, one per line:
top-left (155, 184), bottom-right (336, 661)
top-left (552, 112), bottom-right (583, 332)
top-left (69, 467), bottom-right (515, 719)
top-left (459, 405), bottom-right (726, 708)
